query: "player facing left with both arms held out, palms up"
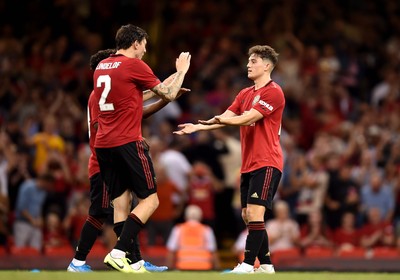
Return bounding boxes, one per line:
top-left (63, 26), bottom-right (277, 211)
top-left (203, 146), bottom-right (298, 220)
top-left (174, 45), bottom-right (285, 274)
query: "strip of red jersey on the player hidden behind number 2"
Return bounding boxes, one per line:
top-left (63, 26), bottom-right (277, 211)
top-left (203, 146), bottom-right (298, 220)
top-left (87, 91), bottom-right (100, 178)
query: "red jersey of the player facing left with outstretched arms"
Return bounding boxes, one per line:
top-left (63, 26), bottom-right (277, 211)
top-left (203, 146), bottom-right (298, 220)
top-left (228, 81), bottom-right (285, 173)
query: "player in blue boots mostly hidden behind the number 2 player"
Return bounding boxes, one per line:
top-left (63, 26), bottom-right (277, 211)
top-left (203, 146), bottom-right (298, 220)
top-left (67, 49), bottom-right (189, 272)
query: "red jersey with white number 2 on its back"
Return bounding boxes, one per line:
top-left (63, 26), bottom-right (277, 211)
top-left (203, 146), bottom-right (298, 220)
top-left (93, 54), bottom-right (160, 148)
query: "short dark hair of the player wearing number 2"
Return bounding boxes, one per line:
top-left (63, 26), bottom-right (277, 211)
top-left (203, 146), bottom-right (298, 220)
top-left (115, 24), bottom-right (149, 50)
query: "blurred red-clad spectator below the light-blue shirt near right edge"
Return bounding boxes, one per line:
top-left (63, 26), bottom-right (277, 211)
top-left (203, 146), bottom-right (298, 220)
top-left (360, 208), bottom-right (395, 249)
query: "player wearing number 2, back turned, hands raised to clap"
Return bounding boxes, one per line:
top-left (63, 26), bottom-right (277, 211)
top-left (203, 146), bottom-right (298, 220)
top-left (93, 24), bottom-right (191, 273)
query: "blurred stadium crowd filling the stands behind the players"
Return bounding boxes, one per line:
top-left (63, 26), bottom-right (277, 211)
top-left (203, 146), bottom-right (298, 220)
top-left (0, 0), bottom-right (400, 262)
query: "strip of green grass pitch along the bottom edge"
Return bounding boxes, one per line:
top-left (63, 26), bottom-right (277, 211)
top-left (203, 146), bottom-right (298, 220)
top-left (0, 270), bottom-right (400, 280)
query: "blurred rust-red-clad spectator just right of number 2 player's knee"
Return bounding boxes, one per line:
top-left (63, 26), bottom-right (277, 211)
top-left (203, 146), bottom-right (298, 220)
top-left (146, 161), bottom-right (184, 246)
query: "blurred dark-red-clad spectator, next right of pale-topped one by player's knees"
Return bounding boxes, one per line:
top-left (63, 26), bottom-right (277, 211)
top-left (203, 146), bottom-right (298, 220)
top-left (300, 210), bottom-right (333, 249)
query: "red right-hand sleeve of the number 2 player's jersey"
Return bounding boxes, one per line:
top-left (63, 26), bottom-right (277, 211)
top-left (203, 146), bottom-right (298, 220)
top-left (131, 59), bottom-right (161, 90)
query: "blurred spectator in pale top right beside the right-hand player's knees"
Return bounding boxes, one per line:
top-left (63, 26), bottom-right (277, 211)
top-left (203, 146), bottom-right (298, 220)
top-left (266, 200), bottom-right (300, 253)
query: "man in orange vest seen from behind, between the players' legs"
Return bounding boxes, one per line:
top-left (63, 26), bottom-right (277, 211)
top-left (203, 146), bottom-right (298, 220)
top-left (167, 205), bottom-right (219, 270)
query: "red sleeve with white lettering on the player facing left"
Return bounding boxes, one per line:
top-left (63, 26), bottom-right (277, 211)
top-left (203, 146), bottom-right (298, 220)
top-left (253, 88), bottom-right (284, 117)
